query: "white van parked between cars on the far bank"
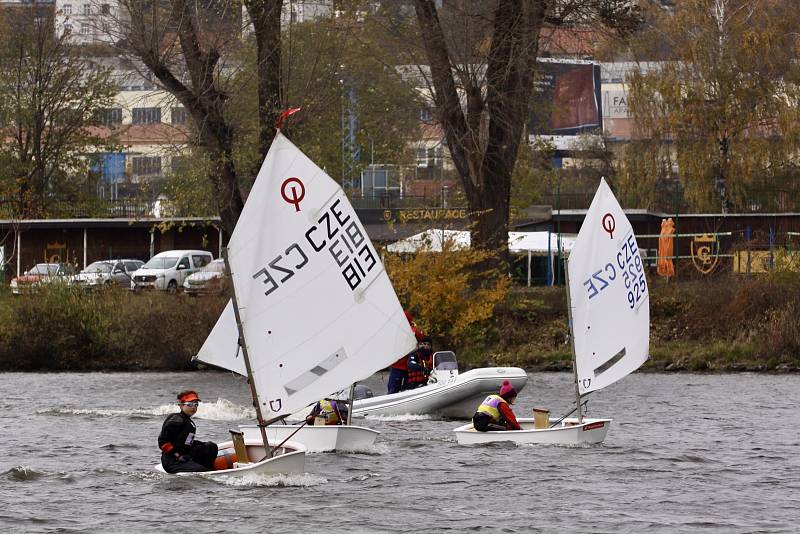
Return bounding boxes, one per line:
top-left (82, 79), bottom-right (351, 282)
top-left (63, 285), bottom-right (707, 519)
top-left (131, 250), bottom-right (214, 293)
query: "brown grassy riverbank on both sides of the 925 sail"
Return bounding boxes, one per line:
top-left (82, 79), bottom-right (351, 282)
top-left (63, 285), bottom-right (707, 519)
top-left (478, 273), bottom-right (800, 372)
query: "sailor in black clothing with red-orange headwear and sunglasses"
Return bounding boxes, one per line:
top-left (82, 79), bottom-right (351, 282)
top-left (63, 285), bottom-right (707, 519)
top-left (158, 389), bottom-right (217, 473)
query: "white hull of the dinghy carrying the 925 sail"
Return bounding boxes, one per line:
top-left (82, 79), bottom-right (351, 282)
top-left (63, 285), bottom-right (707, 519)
top-left (453, 417), bottom-right (612, 445)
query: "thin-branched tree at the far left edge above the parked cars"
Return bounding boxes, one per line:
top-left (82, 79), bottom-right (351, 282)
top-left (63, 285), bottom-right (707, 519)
top-left (0, 4), bottom-right (117, 218)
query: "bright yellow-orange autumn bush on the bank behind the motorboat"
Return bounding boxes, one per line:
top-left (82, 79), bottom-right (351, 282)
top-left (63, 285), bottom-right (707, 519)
top-left (384, 238), bottom-right (510, 350)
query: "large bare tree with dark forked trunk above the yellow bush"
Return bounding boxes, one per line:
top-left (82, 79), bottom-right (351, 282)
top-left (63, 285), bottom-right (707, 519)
top-left (406, 0), bottom-right (638, 264)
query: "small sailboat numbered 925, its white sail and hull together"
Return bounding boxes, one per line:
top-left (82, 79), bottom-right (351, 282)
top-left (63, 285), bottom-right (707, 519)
top-left (454, 178), bottom-right (650, 445)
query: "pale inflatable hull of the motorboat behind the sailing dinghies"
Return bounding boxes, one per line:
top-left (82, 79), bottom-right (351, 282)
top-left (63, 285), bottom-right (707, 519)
top-left (353, 367), bottom-right (528, 419)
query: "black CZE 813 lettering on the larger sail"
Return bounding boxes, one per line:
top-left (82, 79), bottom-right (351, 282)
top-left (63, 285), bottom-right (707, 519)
top-left (253, 199), bottom-right (378, 296)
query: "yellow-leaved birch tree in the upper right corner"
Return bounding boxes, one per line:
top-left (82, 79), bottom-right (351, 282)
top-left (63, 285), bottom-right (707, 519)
top-left (620, 0), bottom-right (800, 212)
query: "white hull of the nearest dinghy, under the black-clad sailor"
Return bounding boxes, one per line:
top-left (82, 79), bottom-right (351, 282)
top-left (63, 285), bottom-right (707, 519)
top-left (155, 437), bottom-right (306, 479)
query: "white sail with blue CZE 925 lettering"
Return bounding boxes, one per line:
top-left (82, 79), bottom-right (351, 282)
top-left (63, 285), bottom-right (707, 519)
top-left (568, 179), bottom-right (650, 395)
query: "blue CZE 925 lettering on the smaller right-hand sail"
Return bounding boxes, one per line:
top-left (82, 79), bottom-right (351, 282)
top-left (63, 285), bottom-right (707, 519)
top-left (583, 232), bottom-right (647, 309)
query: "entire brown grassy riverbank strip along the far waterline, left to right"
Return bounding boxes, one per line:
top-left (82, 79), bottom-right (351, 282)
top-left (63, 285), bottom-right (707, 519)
top-left (0, 273), bottom-right (800, 372)
